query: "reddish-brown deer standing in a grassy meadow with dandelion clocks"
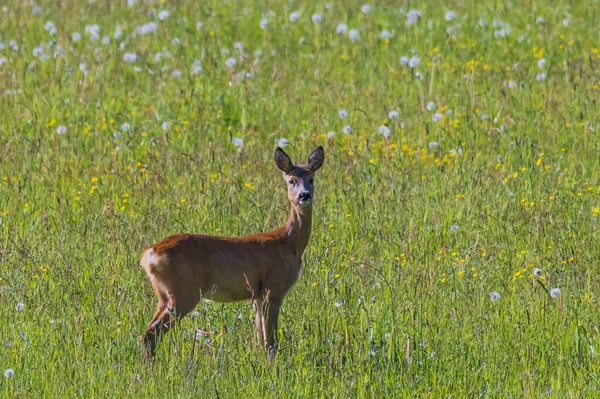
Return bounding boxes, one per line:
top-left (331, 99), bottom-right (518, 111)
top-left (140, 147), bottom-right (325, 358)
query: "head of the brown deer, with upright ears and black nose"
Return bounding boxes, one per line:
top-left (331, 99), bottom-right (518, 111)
top-left (275, 146), bottom-right (325, 208)
